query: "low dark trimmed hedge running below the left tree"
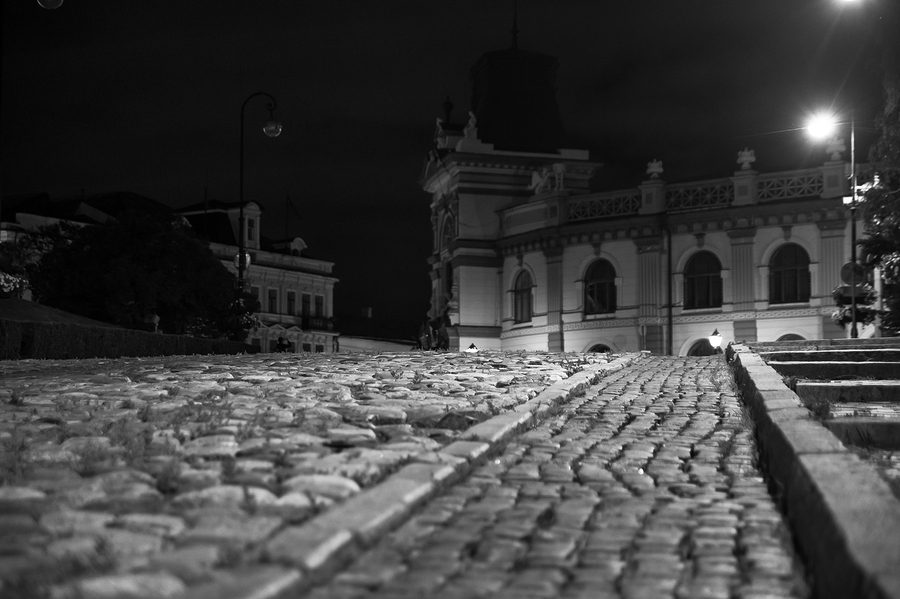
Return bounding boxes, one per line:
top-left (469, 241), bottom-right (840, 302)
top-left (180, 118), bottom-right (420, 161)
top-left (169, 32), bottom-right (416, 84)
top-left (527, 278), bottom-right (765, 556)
top-left (0, 320), bottom-right (253, 360)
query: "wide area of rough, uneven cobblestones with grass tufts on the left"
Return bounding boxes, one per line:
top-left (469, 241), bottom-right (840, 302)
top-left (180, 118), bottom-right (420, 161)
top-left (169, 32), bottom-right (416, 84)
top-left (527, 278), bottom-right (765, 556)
top-left (0, 352), bottom-right (609, 598)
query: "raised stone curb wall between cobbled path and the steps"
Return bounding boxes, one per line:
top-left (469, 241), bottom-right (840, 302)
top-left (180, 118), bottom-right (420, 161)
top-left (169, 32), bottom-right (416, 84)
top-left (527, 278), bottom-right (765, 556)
top-left (728, 345), bottom-right (900, 599)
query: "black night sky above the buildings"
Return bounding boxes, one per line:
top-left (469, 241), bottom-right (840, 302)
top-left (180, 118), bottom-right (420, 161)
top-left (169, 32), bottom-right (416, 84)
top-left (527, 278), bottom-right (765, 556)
top-left (0, 0), bottom-right (894, 337)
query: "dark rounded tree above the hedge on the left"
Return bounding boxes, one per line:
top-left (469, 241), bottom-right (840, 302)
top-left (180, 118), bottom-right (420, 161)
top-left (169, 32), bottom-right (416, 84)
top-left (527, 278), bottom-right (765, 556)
top-left (30, 212), bottom-right (258, 340)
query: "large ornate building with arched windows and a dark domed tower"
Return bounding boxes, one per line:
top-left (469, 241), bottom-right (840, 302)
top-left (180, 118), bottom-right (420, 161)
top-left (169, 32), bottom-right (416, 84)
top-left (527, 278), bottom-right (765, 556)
top-left (422, 47), bottom-right (862, 355)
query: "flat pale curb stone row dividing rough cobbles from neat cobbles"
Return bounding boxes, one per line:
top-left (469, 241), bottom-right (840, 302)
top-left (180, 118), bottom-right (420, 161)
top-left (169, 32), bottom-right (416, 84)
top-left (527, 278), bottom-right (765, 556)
top-left (253, 352), bottom-right (647, 599)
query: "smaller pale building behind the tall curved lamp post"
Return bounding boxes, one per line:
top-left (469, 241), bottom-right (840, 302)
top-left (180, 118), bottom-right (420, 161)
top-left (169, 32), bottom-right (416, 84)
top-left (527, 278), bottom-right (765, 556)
top-left (178, 201), bottom-right (339, 353)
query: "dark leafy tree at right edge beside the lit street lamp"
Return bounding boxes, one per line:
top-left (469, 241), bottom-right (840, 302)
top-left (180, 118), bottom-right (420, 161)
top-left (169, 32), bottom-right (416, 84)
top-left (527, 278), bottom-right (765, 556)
top-left (860, 3), bottom-right (900, 335)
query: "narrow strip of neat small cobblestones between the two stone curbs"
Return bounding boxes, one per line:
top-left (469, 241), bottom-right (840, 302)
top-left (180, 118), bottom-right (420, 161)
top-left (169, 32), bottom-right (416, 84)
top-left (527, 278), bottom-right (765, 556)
top-left (304, 357), bottom-right (809, 599)
